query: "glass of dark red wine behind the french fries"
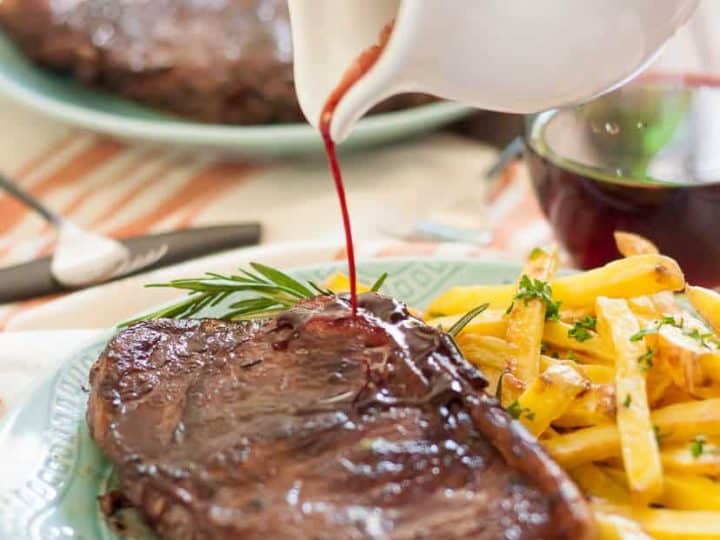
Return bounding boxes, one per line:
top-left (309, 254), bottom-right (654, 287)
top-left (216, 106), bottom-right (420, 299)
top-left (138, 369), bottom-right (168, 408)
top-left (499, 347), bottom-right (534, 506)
top-left (526, 74), bottom-right (720, 287)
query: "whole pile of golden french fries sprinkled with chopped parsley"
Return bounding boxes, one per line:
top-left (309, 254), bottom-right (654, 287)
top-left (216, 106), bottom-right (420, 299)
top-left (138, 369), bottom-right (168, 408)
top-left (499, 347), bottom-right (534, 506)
top-left (426, 233), bottom-right (720, 540)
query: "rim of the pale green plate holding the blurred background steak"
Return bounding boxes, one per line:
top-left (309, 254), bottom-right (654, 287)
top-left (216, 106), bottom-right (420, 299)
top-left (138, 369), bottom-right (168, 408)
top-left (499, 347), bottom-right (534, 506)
top-left (0, 32), bottom-right (473, 156)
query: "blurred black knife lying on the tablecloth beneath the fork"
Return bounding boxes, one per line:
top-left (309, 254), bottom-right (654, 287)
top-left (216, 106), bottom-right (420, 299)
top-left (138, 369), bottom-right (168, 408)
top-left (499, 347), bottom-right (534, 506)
top-left (0, 223), bottom-right (261, 303)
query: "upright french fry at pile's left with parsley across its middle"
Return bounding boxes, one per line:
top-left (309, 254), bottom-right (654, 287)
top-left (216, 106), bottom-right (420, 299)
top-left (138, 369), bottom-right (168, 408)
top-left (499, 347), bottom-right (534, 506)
top-left (505, 250), bottom-right (557, 390)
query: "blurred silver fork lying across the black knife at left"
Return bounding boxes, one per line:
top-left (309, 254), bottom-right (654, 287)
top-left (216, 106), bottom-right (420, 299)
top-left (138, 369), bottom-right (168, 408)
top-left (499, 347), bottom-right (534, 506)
top-left (0, 174), bottom-right (167, 288)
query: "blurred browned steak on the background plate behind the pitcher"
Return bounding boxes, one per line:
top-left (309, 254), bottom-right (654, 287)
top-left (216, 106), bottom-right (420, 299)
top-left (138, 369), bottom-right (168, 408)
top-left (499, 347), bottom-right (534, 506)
top-left (0, 0), bottom-right (429, 124)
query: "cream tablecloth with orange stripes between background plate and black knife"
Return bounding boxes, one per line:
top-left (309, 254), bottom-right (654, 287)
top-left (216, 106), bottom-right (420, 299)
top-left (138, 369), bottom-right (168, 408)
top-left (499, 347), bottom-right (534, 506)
top-left (0, 97), bottom-right (550, 329)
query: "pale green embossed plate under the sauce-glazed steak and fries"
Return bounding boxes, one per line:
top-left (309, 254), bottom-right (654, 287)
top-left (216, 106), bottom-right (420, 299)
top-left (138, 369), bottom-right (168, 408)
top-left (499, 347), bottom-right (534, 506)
top-left (0, 259), bottom-right (520, 540)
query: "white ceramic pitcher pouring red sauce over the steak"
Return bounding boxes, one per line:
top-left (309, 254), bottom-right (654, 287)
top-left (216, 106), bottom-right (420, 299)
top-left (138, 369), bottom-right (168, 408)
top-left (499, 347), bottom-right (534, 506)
top-left (288, 0), bottom-right (698, 141)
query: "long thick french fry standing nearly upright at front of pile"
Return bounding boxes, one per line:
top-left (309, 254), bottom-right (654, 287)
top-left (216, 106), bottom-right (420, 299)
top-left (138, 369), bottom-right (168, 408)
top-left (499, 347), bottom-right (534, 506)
top-left (595, 297), bottom-right (663, 503)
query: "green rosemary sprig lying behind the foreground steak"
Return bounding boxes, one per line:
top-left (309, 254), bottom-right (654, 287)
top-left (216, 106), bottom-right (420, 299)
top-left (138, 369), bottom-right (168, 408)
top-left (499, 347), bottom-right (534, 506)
top-left (120, 262), bottom-right (387, 328)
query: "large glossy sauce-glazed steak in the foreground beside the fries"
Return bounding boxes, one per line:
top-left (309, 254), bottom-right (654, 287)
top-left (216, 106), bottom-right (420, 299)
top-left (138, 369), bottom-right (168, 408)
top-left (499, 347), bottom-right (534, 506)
top-left (88, 293), bottom-right (594, 540)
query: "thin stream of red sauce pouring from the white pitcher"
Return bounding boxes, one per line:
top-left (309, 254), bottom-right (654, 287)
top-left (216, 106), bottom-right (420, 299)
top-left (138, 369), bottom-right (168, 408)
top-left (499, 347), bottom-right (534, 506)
top-left (319, 22), bottom-right (393, 317)
